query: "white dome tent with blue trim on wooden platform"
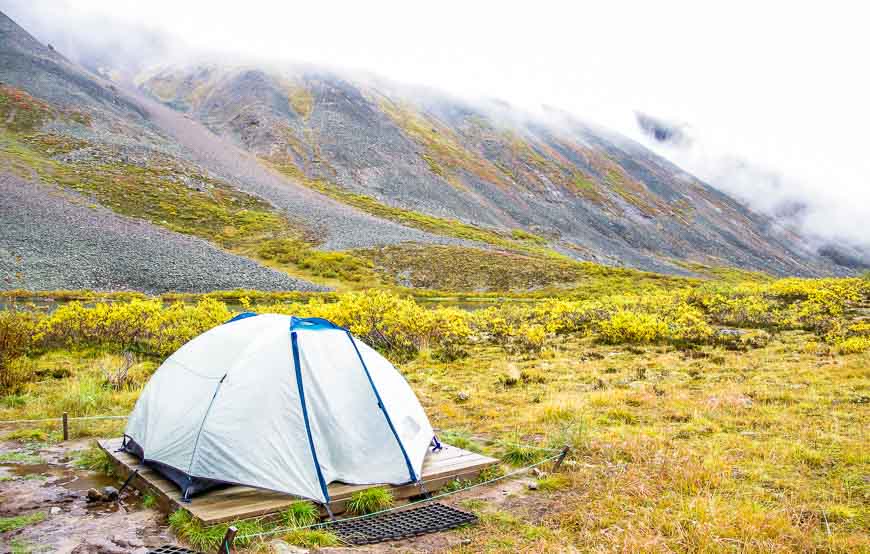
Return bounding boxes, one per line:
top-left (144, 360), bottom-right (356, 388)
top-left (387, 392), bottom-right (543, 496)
top-left (124, 314), bottom-right (437, 506)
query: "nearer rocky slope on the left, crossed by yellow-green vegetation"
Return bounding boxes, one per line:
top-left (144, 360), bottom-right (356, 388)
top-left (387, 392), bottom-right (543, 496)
top-left (0, 10), bottom-right (459, 292)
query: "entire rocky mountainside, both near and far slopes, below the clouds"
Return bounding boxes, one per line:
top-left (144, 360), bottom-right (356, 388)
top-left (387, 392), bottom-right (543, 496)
top-left (0, 10), bottom-right (853, 292)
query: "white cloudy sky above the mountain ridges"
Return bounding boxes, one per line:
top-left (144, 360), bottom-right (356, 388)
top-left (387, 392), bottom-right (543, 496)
top-left (6, 0), bottom-right (870, 247)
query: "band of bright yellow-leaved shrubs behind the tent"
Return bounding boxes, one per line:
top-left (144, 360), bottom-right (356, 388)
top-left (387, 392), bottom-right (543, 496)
top-left (0, 278), bottom-right (870, 391)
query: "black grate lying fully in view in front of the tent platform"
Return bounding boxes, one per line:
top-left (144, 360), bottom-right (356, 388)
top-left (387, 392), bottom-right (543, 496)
top-left (327, 502), bottom-right (477, 545)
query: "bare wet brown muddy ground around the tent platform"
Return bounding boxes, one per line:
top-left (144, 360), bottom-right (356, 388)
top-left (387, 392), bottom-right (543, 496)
top-left (0, 439), bottom-right (540, 554)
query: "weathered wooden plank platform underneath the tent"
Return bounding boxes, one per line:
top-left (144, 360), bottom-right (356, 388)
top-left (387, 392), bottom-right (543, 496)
top-left (98, 438), bottom-right (498, 525)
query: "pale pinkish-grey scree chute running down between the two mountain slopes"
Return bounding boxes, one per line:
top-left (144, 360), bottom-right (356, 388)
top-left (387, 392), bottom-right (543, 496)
top-left (128, 91), bottom-right (465, 250)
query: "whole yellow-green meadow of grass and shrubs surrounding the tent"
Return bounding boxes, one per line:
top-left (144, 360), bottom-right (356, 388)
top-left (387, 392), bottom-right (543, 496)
top-left (0, 275), bottom-right (870, 552)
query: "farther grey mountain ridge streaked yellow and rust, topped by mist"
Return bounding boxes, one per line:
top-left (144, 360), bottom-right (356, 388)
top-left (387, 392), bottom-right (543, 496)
top-left (140, 64), bottom-right (856, 274)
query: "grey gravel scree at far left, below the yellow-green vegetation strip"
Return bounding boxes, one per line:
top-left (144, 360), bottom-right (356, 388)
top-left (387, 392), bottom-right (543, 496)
top-left (0, 173), bottom-right (322, 293)
